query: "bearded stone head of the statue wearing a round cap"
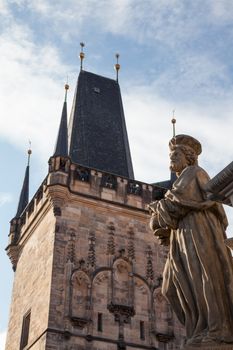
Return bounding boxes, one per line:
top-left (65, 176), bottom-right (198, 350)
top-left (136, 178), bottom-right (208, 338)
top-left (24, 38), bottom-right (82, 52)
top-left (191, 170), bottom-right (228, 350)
top-left (169, 135), bottom-right (202, 175)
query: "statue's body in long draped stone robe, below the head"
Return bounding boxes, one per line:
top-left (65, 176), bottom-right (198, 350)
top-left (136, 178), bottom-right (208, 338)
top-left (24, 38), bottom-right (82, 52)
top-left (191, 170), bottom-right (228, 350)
top-left (150, 166), bottom-right (233, 343)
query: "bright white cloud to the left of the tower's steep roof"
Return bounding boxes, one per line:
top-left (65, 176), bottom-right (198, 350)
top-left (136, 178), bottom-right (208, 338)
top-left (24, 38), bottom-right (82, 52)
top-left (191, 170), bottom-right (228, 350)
top-left (0, 18), bottom-right (74, 161)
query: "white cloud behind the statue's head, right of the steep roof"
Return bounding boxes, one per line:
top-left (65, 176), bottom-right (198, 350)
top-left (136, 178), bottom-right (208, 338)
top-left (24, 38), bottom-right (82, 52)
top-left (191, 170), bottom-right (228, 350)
top-left (123, 87), bottom-right (233, 182)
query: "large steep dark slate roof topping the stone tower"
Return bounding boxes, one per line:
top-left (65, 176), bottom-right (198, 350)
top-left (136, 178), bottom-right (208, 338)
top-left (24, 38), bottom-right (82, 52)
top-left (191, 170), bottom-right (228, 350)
top-left (68, 70), bottom-right (134, 179)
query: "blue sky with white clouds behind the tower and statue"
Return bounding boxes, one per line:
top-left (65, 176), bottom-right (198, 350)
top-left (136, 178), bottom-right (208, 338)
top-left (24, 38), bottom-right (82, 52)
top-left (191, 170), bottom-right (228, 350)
top-left (0, 0), bottom-right (233, 349)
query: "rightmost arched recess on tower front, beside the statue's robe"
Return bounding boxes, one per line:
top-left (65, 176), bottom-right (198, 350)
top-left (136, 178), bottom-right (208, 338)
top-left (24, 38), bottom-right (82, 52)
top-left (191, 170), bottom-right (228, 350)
top-left (153, 288), bottom-right (173, 338)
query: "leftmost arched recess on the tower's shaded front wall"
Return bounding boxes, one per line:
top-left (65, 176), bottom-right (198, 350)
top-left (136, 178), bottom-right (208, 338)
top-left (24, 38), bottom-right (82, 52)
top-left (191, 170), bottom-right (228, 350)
top-left (70, 270), bottom-right (91, 327)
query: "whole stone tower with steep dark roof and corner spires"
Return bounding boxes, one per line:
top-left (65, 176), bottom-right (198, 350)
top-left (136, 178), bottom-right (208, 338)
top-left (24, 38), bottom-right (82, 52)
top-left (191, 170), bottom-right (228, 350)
top-left (6, 66), bottom-right (182, 350)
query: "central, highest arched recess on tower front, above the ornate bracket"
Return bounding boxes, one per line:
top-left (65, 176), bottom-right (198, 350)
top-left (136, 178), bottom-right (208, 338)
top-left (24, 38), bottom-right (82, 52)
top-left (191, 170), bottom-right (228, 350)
top-left (111, 258), bottom-right (134, 306)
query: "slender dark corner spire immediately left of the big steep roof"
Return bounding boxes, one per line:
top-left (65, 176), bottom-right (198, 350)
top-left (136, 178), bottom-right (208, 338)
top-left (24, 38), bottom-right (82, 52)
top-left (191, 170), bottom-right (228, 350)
top-left (53, 84), bottom-right (69, 157)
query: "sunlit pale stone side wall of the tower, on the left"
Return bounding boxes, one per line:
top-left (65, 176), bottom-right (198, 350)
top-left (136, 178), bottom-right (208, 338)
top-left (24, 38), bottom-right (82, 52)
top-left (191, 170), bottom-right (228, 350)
top-left (6, 202), bottom-right (55, 350)
